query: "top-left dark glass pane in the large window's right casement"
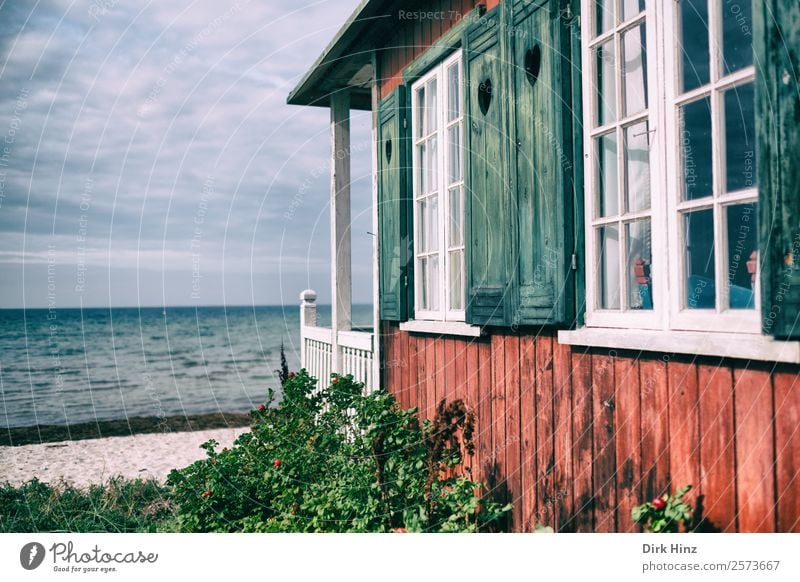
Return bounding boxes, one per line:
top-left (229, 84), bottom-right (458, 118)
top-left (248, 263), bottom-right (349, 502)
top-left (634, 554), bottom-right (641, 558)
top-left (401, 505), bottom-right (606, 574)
top-left (678, 0), bottom-right (710, 92)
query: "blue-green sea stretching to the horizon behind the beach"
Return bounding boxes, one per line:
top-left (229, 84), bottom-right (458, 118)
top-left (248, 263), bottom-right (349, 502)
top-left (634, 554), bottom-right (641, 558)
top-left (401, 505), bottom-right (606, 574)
top-left (0, 305), bottom-right (372, 429)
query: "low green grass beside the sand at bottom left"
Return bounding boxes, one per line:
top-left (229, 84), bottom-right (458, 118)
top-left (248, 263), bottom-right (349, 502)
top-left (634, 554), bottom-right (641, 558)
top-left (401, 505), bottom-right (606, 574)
top-left (0, 478), bottom-right (173, 533)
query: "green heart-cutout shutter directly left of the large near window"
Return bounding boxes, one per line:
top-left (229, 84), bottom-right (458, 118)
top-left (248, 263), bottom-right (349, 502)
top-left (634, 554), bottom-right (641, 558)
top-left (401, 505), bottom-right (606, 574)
top-left (507, 0), bottom-right (574, 325)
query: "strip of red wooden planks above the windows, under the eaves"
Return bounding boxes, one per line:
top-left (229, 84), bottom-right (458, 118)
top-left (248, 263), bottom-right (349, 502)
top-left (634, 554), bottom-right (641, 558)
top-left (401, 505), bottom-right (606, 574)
top-left (378, 0), bottom-right (500, 97)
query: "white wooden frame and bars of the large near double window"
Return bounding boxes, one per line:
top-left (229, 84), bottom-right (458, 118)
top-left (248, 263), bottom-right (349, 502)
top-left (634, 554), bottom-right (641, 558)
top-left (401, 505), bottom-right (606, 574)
top-left (581, 0), bottom-right (761, 335)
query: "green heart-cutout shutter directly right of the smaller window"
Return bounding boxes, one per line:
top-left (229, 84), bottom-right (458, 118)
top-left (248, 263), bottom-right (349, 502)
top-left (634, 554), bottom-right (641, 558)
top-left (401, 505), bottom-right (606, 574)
top-left (463, 8), bottom-right (511, 325)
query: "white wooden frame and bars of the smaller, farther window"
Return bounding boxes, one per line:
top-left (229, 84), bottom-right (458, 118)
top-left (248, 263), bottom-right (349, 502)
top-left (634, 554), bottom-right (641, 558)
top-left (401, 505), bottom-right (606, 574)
top-left (411, 49), bottom-right (466, 322)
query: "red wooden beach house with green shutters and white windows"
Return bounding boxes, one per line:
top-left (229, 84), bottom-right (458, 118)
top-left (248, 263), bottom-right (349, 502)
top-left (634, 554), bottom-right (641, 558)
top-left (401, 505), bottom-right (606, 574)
top-left (288, 0), bottom-right (800, 532)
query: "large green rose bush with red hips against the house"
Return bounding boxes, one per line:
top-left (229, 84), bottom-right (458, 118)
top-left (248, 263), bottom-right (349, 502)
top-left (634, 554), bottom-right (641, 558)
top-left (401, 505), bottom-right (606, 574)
top-left (167, 371), bottom-right (510, 532)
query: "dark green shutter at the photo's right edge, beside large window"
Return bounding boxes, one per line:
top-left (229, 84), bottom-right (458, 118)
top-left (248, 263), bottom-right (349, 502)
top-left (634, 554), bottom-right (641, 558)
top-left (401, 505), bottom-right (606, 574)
top-left (754, 0), bottom-right (800, 339)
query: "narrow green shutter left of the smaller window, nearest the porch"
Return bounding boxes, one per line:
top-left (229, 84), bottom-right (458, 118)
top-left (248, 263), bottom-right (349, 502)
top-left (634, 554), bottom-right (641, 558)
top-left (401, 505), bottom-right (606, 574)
top-left (378, 86), bottom-right (413, 321)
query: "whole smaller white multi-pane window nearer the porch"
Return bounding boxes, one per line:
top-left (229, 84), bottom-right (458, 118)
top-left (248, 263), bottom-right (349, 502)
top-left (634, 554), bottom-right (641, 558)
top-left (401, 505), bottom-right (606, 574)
top-left (412, 52), bottom-right (464, 321)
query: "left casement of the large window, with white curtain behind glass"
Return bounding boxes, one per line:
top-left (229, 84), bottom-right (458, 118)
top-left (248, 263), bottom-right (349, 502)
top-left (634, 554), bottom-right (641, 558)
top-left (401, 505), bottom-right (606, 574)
top-left (584, 0), bottom-right (652, 326)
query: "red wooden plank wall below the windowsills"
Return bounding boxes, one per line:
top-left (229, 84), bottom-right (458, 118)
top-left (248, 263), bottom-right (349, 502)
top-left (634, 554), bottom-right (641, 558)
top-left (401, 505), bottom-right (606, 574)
top-left (382, 322), bottom-right (800, 532)
